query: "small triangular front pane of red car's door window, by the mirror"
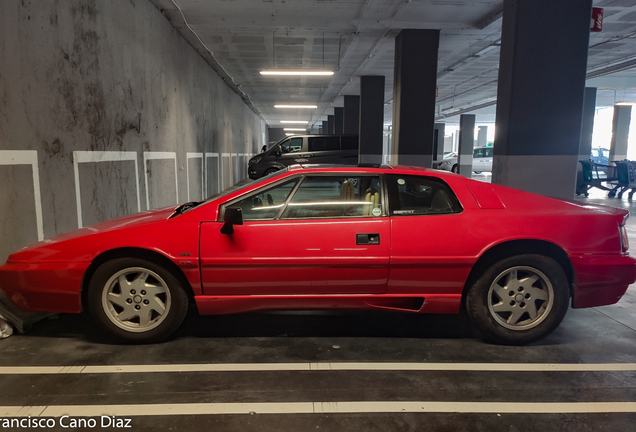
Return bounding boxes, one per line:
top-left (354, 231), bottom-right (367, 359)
top-left (226, 179), bottom-right (298, 220)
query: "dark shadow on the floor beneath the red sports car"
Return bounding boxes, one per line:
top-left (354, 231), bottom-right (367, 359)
top-left (17, 310), bottom-right (480, 343)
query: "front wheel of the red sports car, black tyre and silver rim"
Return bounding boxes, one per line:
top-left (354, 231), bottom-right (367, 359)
top-left (87, 258), bottom-right (188, 343)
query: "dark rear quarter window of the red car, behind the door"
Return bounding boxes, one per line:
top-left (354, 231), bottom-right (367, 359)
top-left (387, 174), bottom-right (462, 216)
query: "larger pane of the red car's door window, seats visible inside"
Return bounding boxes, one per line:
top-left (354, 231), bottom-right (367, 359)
top-left (281, 176), bottom-right (383, 219)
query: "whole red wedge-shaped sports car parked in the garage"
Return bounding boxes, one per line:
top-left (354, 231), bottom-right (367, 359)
top-left (0, 165), bottom-right (636, 344)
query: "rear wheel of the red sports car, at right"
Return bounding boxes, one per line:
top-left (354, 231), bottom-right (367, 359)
top-left (466, 254), bottom-right (570, 345)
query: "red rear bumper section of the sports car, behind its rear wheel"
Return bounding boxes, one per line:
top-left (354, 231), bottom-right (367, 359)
top-left (570, 255), bottom-right (636, 308)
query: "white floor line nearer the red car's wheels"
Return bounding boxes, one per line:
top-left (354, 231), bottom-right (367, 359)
top-left (0, 362), bottom-right (636, 375)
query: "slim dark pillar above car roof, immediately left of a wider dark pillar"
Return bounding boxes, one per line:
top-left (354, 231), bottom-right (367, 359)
top-left (358, 76), bottom-right (384, 164)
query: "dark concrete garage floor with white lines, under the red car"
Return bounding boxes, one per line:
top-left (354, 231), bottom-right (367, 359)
top-left (0, 184), bottom-right (636, 432)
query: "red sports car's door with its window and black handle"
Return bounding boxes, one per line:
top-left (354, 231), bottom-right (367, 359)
top-left (200, 175), bottom-right (391, 295)
